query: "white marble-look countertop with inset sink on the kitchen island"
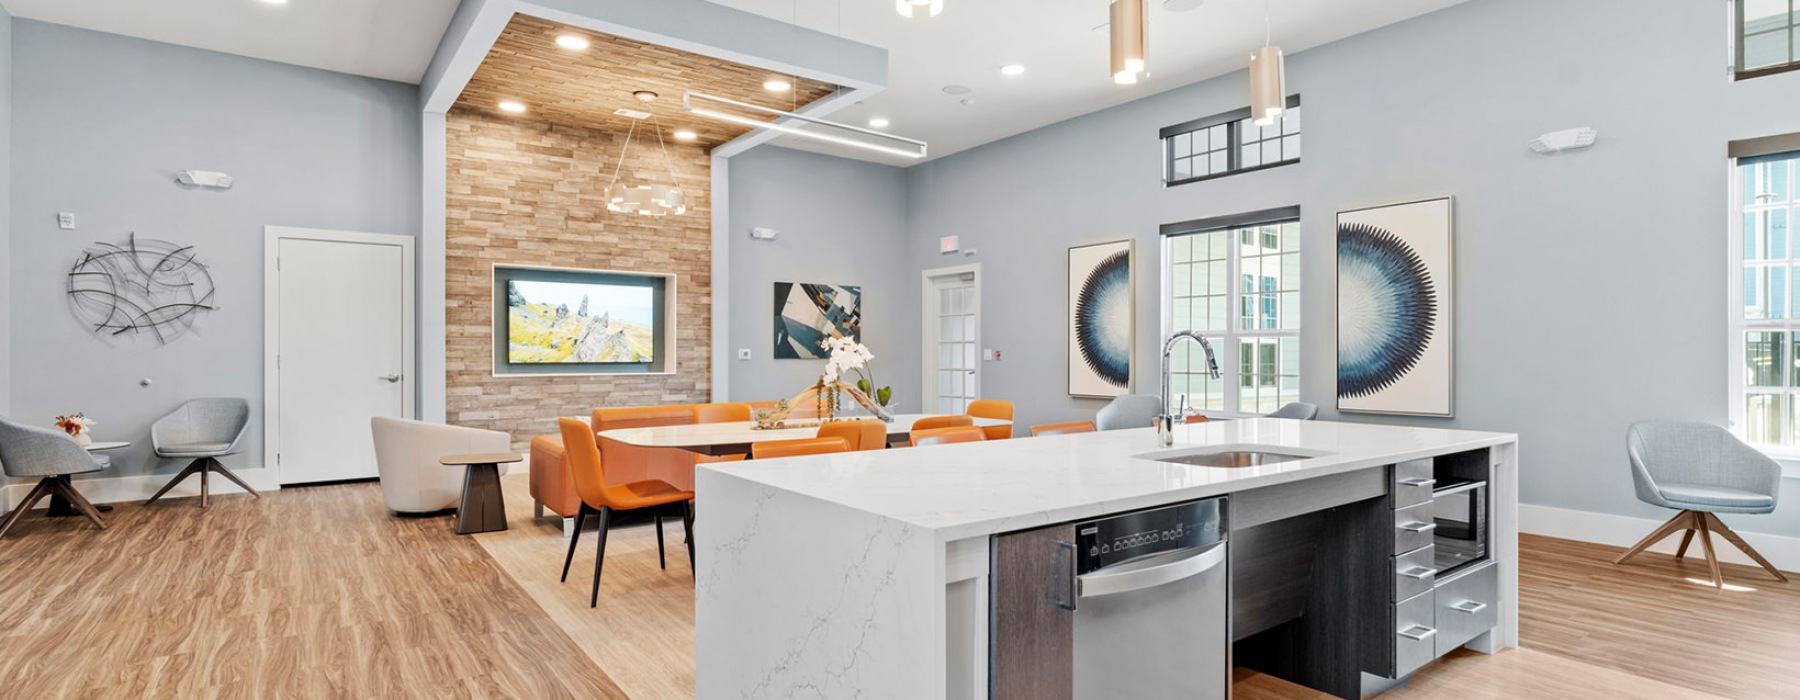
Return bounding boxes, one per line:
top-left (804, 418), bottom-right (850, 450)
top-left (698, 417), bottom-right (1517, 542)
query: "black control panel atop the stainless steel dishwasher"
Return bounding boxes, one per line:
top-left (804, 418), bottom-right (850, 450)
top-left (1075, 498), bottom-right (1224, 574)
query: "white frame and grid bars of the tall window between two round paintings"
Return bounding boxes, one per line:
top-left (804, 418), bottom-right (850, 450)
top-left (1157, 207), bottom-right (1307, 413)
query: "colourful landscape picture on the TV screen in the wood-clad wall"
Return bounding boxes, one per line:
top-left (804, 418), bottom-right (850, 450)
top-left (506, 279), bottom-right (655, 365)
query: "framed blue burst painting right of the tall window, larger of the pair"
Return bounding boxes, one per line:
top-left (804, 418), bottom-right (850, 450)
top-left (1337, 198), bottom-right (1454, 417)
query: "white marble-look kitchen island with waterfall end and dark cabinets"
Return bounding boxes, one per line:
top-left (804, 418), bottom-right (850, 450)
top-left (695, 419), bottom-right (1517, 700)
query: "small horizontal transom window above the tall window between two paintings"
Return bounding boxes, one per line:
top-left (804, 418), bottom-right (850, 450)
top-left (1161, 95), bottom-right (1300, 185)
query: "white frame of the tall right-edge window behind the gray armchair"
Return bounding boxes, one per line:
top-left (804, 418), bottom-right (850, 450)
top-left (1724, 151), bottom-right (1800, 479)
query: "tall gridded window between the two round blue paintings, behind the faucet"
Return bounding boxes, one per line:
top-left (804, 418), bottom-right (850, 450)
top-left (1163, 207), bottom-right (1300, 416)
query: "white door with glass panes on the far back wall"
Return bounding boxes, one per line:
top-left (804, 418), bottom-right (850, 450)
top-left (922, 266), bottom-right (981, 414)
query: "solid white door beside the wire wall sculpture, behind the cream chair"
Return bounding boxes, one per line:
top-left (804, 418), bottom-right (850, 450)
top-left (268, 229), bottom-right (412, 484)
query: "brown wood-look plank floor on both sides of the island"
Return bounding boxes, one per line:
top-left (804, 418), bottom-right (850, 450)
top-left (0, 473), bottom-right (1800, 700)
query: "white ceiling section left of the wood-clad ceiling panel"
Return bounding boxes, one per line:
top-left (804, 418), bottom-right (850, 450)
top-left (0, 0), bottom-right (457, 83)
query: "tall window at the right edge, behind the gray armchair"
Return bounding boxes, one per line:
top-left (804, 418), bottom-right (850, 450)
top-left (1732, 153), bottom-right (1800, 453)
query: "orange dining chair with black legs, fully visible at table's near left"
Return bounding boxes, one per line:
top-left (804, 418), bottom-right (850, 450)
top-left (556, 417), bottom-right (693, 608)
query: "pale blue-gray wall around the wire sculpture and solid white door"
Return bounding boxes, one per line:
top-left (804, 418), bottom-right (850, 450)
top-left (7, 20), bottom-right (421, 477)
